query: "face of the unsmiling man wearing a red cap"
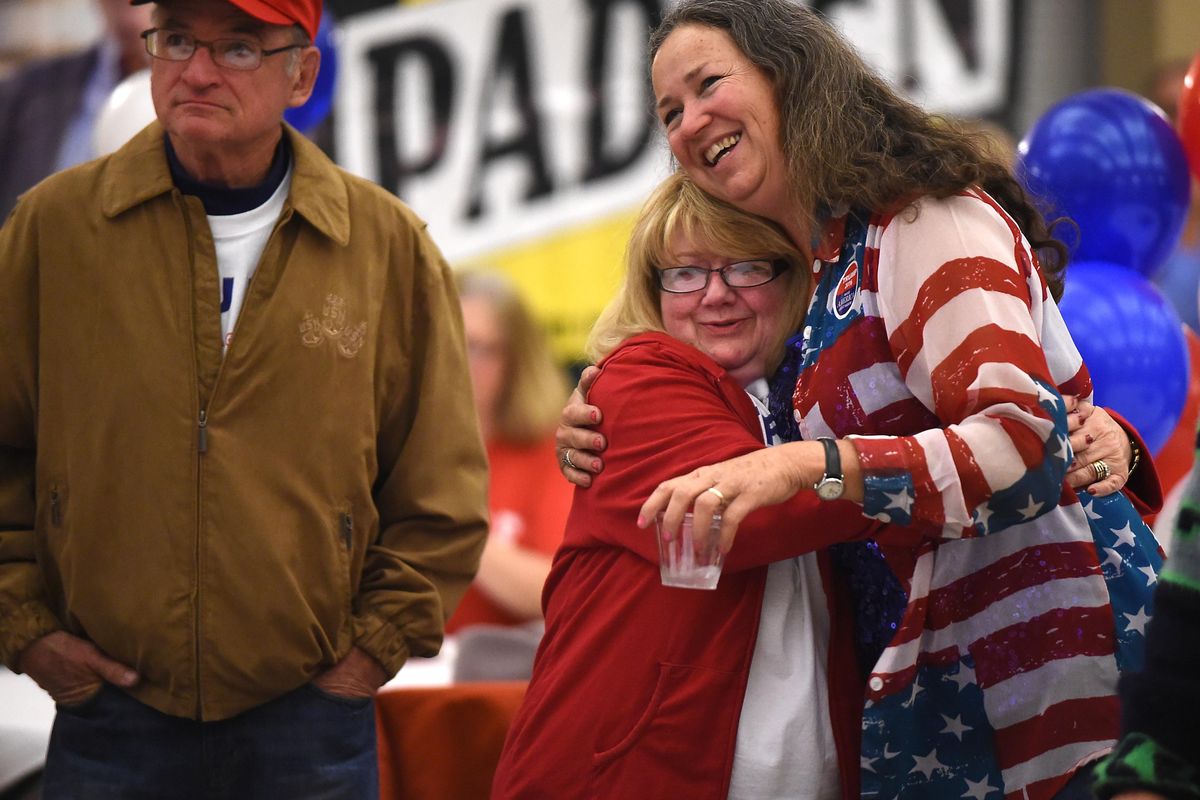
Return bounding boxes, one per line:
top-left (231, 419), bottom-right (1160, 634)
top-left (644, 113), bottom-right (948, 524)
top-left (150, 0), bottom-right (320, 180)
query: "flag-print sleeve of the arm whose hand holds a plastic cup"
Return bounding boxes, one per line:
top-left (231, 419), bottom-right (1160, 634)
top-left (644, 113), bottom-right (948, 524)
top-left (854, 192), bottom-right (1070, 537)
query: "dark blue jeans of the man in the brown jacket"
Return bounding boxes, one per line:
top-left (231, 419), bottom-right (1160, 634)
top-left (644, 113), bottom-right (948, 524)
top-left (42, 685), bottom-right (379, 800)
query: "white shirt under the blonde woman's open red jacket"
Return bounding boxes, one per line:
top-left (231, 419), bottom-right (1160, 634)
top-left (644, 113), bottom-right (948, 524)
top-left (730, 380), bottom-right (841, 800)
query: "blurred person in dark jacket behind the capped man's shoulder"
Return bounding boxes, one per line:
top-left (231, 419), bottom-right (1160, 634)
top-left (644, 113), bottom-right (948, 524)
top-left (0, 0), bottom-right (150, 222)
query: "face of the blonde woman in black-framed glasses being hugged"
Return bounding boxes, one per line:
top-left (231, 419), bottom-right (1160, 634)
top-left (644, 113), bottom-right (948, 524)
top-left (659, 227), bottom-right (794, 386)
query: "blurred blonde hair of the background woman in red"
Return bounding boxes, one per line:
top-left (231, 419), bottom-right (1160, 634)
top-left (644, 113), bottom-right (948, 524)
top-left (455, 269), bottom-right (570, 444)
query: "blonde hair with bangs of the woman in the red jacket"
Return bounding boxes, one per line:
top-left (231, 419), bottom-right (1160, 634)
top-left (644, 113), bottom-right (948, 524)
top-left (586, 170), bottom-right (810, 369)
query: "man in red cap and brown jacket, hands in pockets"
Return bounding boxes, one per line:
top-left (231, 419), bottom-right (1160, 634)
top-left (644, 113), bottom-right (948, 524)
top-left (0, 0), bottom-right (487, 800)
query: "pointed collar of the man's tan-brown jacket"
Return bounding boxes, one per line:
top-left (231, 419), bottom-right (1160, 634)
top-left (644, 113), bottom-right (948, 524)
top-left (101, 121), bottom-right (350, 246)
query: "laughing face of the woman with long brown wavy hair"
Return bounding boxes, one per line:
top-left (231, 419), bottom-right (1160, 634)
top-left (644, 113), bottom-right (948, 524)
top-left (650, 24), bottom-right (788, 224)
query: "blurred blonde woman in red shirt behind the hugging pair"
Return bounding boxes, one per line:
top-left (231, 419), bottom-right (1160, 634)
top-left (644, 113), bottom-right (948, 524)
top-left (446, 270), bottom-right (571, 633)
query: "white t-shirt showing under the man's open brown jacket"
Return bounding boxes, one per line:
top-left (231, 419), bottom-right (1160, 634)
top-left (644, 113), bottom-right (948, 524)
top-left (209, 167), bottom-right (292, 349)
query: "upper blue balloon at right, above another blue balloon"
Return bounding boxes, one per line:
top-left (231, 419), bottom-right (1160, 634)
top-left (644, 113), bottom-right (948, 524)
top-left (1018, 89), bottom-right (1192, 275)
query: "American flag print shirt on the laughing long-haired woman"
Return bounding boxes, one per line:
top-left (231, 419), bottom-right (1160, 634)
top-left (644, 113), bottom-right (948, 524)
top-left (790, 191), bottom-right (1162, 800)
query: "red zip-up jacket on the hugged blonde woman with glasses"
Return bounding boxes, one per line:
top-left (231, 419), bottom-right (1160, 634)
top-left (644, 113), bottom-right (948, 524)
top-left (492, 333), bottom-right (883, 800)
